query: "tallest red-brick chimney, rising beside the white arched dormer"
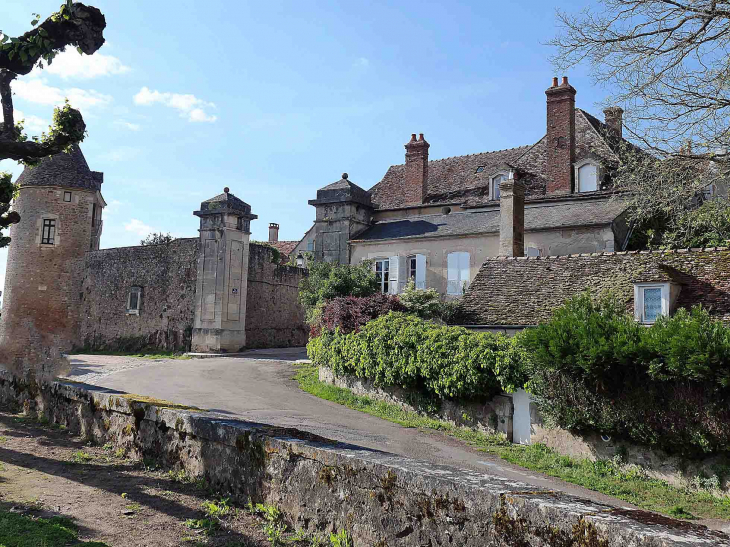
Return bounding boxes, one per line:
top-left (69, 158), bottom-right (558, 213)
top-left (545, 76), bottom-right (576, 195)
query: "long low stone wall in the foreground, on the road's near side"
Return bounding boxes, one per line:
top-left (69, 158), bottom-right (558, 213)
top-left (0, 372), bottom-right (730, 547)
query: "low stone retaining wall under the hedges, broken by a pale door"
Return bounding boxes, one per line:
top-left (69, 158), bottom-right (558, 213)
top-left (319, 367), bottom-right (730, 491)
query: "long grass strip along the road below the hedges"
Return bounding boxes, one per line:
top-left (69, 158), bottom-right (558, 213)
top-left (295, 364), bottom-right (730, 519)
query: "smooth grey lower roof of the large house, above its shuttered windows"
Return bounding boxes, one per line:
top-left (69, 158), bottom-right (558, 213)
top-left (356, 197), bottom-right (626, 241)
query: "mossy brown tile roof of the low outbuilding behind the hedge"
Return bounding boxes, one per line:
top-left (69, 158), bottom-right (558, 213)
top-left (458, 247), bottom-right (730, 326)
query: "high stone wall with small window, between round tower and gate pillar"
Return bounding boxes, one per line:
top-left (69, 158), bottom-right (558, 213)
top-left (80, 238), bottom-right (199, 351)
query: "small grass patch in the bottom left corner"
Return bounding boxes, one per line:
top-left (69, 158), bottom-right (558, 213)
top-left (0, 511), bottom-right (108, 547)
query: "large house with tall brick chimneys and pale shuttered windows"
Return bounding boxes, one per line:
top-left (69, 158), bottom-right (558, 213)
top-left (309, 78), bottom-right (628, 296)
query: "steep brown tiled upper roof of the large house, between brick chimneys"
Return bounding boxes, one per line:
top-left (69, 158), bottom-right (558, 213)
top-left (370, 108), bottom-right (628, 209)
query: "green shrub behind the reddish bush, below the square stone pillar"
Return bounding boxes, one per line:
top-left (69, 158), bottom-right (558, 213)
top-left (299, 261), bottom-right (378, 324)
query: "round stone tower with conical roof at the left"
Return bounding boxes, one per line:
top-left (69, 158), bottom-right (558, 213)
top-left (0, 146), bottom-right (106, 371)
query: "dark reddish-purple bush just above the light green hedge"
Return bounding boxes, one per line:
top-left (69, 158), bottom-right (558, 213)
top-left (317, 293), bottom-right (405, 334)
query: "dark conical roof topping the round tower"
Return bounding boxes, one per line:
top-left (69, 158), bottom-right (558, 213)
top-left (17, 146), bottom-right (104, 190)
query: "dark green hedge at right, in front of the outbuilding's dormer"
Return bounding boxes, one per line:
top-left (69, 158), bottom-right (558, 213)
top-left (521, 294), bottom-right (730, 455)
